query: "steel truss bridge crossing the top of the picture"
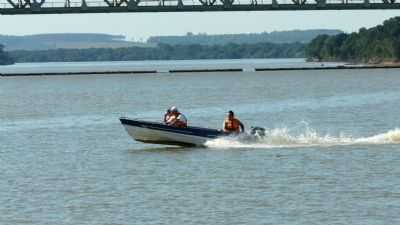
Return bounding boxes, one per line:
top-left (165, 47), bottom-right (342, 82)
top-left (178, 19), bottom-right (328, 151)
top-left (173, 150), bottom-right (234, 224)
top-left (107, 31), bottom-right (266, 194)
top-left (0, 0), bottom-right (400, 15)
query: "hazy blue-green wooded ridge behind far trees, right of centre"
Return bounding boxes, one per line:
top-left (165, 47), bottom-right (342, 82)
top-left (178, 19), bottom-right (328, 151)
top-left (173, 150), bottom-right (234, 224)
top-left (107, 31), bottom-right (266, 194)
top-left (147, 29), bottom-right (343, 45)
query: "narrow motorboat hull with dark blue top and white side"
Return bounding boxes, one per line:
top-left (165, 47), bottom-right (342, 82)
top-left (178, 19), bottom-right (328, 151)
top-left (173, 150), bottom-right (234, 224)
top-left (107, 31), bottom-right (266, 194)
top-left (119, 117), bottom-right (226, 146)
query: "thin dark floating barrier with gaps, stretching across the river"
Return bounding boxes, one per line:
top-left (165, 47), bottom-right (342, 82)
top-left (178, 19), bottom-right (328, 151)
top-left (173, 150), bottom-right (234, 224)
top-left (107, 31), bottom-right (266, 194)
top-left (0, 63), bottom-right (400, 77)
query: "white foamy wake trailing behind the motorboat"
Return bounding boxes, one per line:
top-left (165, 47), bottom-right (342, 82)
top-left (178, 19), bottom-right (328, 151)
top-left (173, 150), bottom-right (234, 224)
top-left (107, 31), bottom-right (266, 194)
top-left (206, 128), bottom-right (400, 148)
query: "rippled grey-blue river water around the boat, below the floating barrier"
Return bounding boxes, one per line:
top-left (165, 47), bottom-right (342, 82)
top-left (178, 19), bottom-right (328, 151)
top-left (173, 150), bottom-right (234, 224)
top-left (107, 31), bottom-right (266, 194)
top-left (0, 61), bottom-right (400, 225)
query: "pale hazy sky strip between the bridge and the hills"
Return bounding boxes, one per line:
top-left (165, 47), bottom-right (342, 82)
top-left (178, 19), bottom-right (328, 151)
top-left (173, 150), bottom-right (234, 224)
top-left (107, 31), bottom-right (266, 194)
top-left (0, 10), bottom-right (400, 40)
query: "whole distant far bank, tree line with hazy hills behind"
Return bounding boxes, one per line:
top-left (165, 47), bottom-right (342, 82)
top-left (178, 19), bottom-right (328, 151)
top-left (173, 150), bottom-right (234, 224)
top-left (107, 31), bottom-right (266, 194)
top-left (5, 30), bottom-right (342, 62)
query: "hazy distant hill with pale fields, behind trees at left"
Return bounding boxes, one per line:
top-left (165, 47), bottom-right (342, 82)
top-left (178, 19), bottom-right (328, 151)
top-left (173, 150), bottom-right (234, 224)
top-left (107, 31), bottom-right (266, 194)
top-left (0, 33), bottom-right (151, 51)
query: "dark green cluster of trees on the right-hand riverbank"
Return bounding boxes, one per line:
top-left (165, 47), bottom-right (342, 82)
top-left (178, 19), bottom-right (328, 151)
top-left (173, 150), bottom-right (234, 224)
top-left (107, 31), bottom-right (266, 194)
top-left (306, 17), bottom-right (400, 63)
